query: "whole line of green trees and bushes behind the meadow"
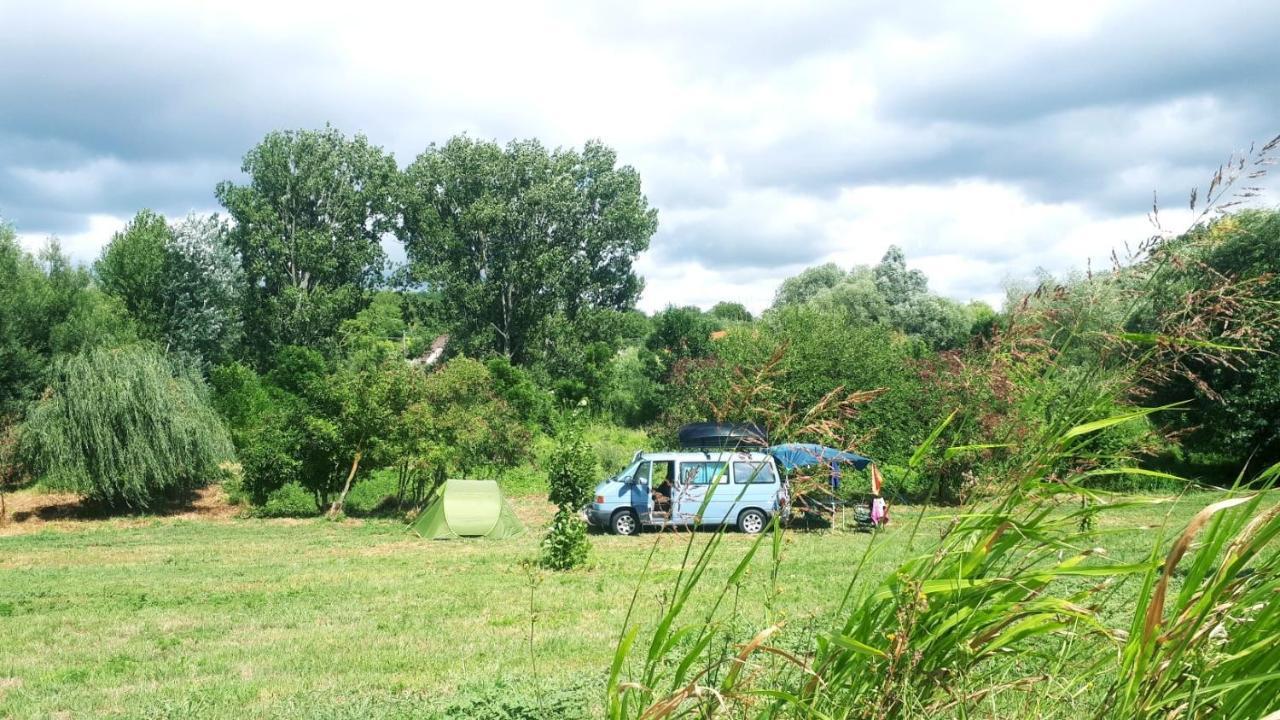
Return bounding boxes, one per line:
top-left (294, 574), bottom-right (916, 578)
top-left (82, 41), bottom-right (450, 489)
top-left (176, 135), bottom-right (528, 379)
top-left (0, 127), bottom-right (1280, 514)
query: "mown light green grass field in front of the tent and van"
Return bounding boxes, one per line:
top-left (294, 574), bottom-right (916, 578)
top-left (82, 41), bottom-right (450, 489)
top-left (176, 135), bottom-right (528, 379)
top-left (0, 484), bottom-right (1244, 719)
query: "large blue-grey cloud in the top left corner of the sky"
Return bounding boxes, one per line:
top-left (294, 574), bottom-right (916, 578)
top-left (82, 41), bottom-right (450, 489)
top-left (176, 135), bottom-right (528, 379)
top-left (0, 3), bottom-right (345, 161)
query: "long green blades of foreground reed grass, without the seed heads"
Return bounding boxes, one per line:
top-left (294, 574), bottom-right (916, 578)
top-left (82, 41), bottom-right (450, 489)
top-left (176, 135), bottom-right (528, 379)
top-left (608, 407), bottom-right (1280, 719)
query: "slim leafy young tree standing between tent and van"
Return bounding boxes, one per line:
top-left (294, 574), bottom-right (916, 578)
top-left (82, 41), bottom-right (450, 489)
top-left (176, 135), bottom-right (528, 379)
top-left (539, 416), bottom-right (596, 570)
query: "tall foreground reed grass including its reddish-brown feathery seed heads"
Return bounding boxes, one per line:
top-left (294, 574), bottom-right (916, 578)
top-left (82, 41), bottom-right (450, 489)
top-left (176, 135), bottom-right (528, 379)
top-left (605, 138), bottom-right (1280, 720)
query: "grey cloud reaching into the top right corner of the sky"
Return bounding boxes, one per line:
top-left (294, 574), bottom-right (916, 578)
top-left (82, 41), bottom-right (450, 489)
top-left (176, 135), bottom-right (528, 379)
top-left (883, 1), bottom-right (1280, 126)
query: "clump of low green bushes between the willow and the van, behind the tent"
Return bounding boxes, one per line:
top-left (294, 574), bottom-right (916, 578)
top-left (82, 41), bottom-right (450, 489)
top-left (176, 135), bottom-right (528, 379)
top-left (222, 340), bottom-right (540, 511)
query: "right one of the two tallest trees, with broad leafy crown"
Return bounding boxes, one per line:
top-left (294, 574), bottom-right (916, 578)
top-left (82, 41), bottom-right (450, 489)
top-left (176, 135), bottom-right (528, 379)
top-left (403, 137), bottom-right (658, 364)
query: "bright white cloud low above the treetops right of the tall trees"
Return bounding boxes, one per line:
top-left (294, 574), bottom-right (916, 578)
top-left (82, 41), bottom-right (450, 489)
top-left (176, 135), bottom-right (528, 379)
top-left (641, 181), bottom-right (1190, 313)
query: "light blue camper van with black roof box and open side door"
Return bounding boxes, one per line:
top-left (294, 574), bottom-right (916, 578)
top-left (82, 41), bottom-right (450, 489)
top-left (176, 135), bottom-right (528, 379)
top-left (585, 423), bottom-right (788, 536)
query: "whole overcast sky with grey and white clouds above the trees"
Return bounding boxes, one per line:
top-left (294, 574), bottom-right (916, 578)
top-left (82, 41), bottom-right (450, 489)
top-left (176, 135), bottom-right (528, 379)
top-left (0, 0), bottom-right (1280, 310)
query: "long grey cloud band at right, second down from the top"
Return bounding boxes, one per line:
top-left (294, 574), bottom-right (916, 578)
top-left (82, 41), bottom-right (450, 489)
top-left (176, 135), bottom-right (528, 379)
top-left (741, 85), bottom-right (1280, 214)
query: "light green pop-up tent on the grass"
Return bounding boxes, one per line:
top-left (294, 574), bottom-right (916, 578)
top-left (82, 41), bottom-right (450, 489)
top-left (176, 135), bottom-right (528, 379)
top-left (410, 480), bottom-right (525, 539)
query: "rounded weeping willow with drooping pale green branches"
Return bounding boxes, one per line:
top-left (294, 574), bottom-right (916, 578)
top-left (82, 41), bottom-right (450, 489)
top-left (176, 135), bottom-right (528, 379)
top-left (22, 347), bottom-right (233, 509)
